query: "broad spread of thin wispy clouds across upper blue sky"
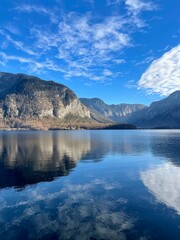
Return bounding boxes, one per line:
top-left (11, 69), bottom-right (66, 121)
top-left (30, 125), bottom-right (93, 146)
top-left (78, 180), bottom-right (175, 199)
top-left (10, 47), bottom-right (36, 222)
top-left (0, 0), bottom-right (158, 82)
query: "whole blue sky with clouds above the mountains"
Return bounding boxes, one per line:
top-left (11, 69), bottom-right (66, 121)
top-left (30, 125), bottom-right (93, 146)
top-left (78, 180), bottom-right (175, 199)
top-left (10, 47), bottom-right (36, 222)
top-left (0, 0), bottom-right (180, 105)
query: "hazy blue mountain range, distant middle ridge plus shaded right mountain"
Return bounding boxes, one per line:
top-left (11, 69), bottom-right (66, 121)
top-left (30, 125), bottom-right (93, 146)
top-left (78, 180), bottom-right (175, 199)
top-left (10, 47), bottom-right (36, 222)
top-left (80, 90), bottom-right (180, 128)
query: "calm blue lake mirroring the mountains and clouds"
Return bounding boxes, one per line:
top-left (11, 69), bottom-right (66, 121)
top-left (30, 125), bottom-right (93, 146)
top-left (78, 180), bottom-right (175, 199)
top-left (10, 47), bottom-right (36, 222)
top-left (0, 130), bottom-right (180, 240)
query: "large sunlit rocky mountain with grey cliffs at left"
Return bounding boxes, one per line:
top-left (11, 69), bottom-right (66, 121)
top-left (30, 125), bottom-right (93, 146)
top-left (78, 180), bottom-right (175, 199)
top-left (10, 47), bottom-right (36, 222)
top-left (0, 73), bottom-right (91, 125)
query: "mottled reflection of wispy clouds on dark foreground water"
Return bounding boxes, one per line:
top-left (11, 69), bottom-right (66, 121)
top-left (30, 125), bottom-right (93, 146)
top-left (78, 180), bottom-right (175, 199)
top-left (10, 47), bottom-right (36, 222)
top-left (0, 179), bottom-right (135, 240)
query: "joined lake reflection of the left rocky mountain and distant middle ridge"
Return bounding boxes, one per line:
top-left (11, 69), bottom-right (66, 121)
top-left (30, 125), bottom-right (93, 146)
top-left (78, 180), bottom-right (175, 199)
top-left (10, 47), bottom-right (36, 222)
top-left (0, 131), bottom-right (148, 188)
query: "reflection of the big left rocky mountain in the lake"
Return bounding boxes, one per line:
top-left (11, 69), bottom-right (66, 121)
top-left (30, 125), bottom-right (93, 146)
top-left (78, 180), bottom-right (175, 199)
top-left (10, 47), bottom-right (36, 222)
top-left (0, 132), bottom-right (91, 187)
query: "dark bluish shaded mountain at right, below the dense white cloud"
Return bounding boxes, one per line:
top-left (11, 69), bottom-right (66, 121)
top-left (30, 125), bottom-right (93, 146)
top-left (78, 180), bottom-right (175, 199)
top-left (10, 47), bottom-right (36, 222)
top-left (128, 91), bottom-right (180, 128)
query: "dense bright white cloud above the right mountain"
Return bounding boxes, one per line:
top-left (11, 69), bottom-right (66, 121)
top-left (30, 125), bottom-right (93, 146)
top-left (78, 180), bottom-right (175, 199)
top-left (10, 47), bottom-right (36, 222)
top-left (138, 45), bottom-right (180, 96)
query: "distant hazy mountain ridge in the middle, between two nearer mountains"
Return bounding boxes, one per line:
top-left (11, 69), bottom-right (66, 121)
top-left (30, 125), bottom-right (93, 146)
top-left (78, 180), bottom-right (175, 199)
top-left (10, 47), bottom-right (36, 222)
top-left (80, 98), bottom-right (147, 122)
